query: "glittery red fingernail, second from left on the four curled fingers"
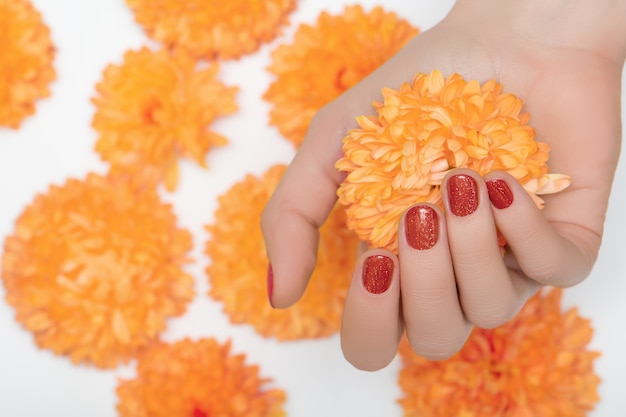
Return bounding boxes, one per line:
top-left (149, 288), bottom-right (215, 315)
top-left (404, 206), bottom-right (439, 250)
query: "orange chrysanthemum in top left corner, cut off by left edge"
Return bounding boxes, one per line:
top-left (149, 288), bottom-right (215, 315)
top-left (0, 0), bottom-right (56, 129)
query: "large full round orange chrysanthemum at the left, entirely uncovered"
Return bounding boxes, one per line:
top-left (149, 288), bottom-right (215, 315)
top-left (2, 174), bottom-right (194, 368)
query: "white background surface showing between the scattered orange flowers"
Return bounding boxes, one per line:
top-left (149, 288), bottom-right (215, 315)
top-left (0, 0), bottom-right (626, 417)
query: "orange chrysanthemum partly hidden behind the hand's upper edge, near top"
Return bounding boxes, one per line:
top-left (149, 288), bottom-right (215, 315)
top-left (263, 6), bottom-right (418, 147)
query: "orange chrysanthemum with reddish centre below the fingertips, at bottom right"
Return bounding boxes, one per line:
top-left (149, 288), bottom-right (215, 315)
top-left (399, 289), bottom-right (600, 417)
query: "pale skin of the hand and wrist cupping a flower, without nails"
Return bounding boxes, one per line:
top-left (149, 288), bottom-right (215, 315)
top-left (261, 0), bottom-right (626, 370)
